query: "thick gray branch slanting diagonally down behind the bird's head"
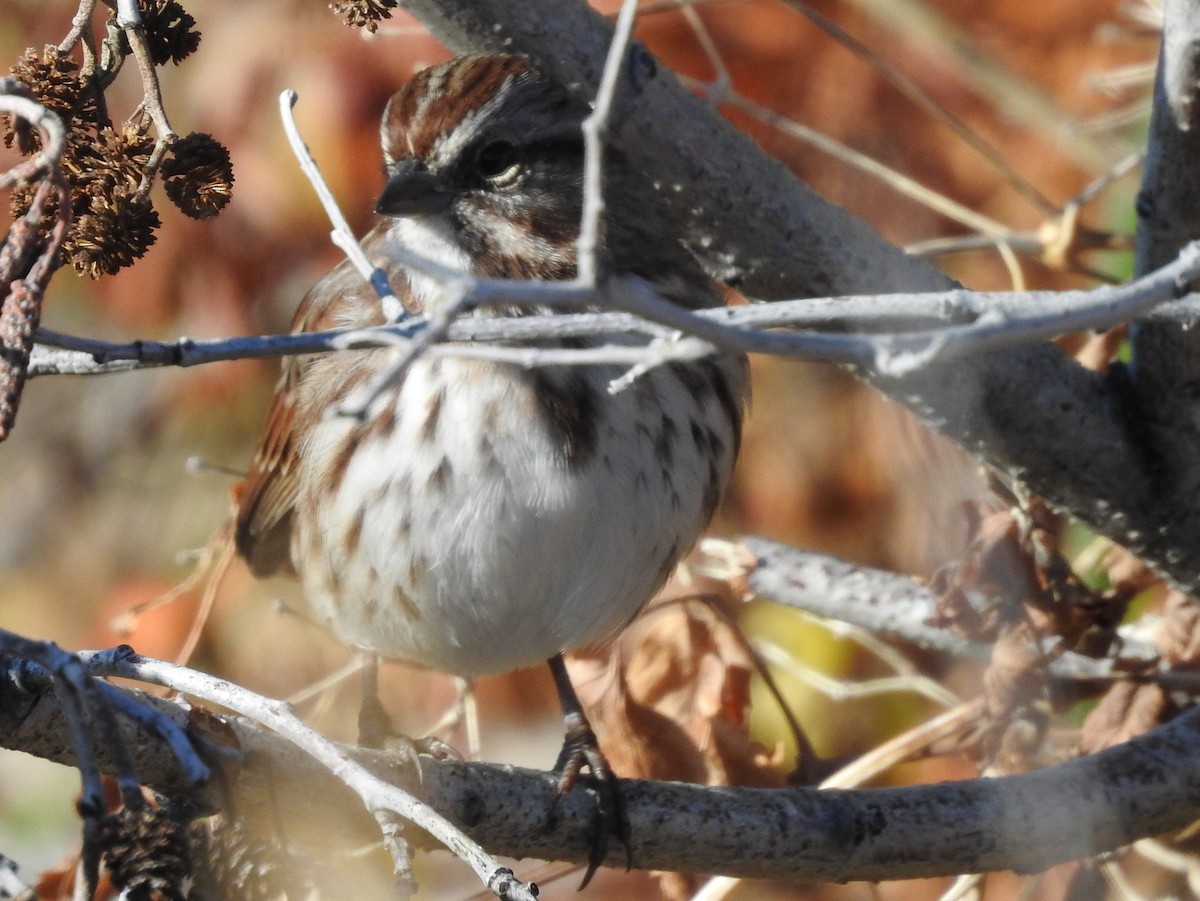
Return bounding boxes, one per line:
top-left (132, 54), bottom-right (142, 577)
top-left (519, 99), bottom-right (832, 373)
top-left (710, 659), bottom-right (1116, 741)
top-left (406, 0), bottom-right (1200, 588)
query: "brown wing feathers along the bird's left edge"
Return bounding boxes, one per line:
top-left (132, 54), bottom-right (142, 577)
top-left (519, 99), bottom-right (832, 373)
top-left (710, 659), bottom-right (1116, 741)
top-left (234, 236), bottom-right (407, 576)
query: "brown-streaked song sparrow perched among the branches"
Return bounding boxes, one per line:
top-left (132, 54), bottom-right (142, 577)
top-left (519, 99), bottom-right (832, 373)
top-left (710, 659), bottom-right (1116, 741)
top-left (236, 55), bottom-right (746, 868)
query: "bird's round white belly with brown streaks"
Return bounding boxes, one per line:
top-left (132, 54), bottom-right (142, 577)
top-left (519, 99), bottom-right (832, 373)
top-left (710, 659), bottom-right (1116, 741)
top-left (293, 359), bottom-right (736, 675)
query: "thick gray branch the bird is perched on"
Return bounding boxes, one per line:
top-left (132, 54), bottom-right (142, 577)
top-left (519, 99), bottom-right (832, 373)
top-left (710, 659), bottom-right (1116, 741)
top-left (7, 657), bottom-right (1200, 881)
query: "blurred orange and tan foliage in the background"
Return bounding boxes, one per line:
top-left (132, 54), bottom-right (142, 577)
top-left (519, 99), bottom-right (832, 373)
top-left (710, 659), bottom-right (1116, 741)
top-left (0, 0), bottom-right (1157, 899)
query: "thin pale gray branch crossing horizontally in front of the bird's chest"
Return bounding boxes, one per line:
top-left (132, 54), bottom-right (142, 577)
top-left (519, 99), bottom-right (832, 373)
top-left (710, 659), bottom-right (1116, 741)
top-left (30, 236), bottom-right (1200, 376)
